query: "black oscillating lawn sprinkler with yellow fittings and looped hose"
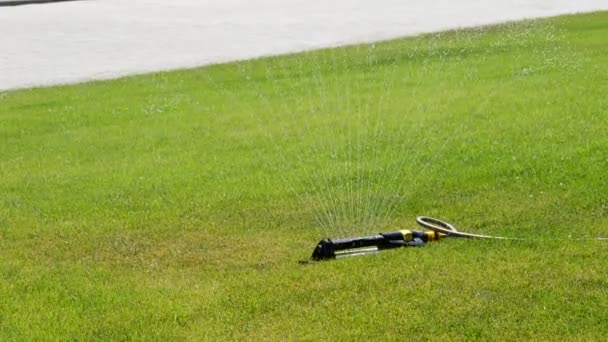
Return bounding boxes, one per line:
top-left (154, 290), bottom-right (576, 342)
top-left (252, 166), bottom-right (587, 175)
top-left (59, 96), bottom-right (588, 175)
top-left (311, 216), bottom-right (521, 261)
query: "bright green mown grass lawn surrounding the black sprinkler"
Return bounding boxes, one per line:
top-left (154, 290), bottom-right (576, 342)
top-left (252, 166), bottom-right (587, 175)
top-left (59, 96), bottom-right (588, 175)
top-left (0, 12), bottom-right (608, 340)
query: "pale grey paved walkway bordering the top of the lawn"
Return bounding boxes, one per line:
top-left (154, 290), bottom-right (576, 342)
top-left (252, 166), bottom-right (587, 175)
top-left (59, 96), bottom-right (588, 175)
top-left (0, 0), bottom-right (608, 90)
